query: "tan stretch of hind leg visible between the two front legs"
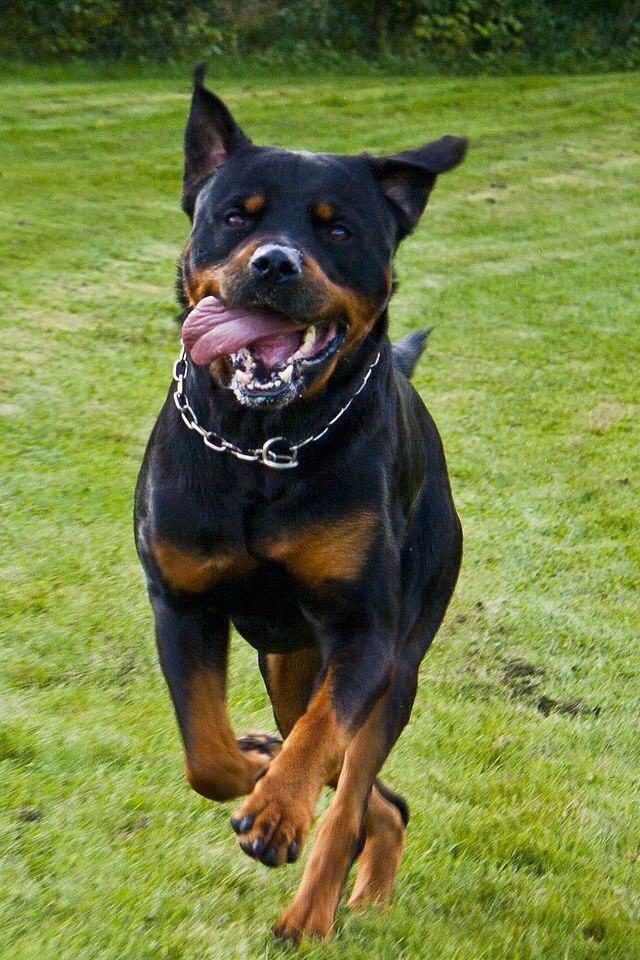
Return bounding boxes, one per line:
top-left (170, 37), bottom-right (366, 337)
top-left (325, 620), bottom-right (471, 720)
top-left (267, 648), bottom-right (320, 737)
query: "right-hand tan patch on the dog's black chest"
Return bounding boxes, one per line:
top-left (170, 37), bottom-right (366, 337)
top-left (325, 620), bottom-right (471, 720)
top-left (265, 510), bottom-right (376, 588)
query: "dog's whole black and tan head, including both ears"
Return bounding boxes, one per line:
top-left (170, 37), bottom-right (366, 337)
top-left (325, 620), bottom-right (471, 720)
top-left (181, 70), bottom-right (466, 408)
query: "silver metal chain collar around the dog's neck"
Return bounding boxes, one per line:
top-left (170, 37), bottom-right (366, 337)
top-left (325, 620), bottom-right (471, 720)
top-left (173, 343), bottom-right (380, 470)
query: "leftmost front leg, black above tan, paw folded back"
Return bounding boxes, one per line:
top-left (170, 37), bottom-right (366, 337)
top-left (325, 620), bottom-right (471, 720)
top-left (151, 592), bottom-right (279, 800)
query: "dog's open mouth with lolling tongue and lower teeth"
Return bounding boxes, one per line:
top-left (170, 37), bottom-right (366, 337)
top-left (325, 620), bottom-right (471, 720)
top-left (182, 297), bottom-right (345, 406)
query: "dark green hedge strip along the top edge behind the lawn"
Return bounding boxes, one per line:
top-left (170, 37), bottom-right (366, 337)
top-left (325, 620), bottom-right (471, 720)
top-left (0, 0), bottom-right (640, 72)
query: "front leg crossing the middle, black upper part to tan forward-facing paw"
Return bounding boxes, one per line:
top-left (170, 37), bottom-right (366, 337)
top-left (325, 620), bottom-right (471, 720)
top-left (232, 611), bottom-right (393, 867)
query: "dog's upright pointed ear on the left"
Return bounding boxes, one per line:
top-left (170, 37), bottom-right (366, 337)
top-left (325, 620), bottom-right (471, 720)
top-left (182, 64), bottom-right (251, 218)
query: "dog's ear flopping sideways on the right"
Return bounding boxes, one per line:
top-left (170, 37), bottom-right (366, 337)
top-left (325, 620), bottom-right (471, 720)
top-left (370, 137), bottom-right (467, 241)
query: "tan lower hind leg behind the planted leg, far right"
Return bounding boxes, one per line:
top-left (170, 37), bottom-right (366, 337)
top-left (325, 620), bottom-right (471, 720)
top-left (348, 786), bottom-right (406, 910)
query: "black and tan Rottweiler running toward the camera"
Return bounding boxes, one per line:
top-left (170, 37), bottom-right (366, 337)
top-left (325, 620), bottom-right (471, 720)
top-left (136, 71), bottom-right (466, 940)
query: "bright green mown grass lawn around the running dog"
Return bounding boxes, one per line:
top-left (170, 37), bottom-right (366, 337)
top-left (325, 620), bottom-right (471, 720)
top-left (0, 74), bottom-right (640, 960)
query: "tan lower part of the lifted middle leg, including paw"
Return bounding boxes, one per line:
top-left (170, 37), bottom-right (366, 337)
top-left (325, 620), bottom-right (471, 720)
top-left (233, 676), bottom-right (348, 866)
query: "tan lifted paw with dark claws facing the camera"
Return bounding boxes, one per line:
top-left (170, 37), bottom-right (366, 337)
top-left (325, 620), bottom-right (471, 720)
top-left (231, 768), bottom-right (313, 867)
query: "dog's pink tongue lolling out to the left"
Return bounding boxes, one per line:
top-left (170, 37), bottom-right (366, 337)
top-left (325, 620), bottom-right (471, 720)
top-left (182, 297), bottom-right (302, 367)
